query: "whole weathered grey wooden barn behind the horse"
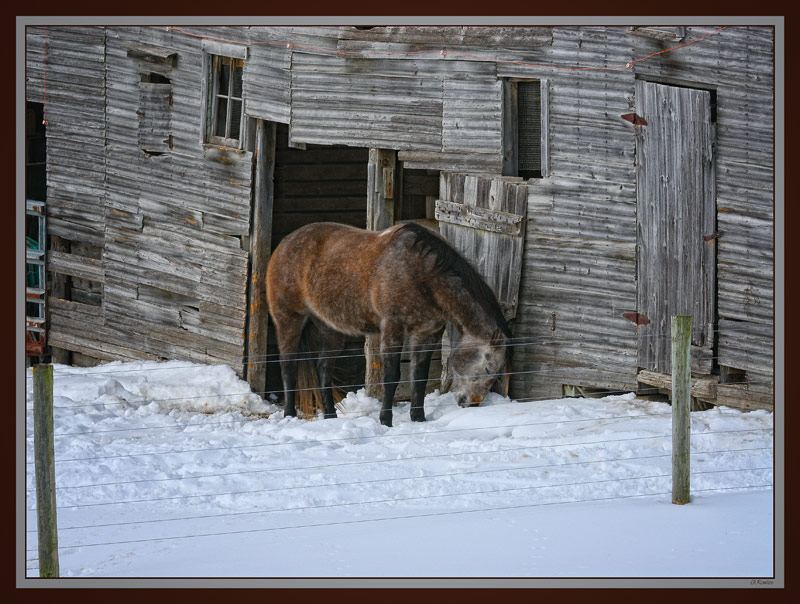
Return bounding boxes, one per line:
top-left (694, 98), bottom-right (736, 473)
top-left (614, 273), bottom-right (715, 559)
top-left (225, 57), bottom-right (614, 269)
top-left (26, 23), bottom-right (775, 408)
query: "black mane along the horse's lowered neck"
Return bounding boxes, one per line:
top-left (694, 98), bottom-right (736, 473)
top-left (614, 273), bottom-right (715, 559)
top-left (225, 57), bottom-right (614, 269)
top-left (397, 222), bottom-right (511, 338)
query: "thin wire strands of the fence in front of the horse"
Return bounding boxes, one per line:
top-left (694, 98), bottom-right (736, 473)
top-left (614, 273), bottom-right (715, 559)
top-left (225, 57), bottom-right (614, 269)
top-left (26, 330), bottom-right (773, 571)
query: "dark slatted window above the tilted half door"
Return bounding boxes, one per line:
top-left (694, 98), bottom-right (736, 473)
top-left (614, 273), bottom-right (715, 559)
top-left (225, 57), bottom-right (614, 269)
top-left (503, 80), bottom-right (547, 179)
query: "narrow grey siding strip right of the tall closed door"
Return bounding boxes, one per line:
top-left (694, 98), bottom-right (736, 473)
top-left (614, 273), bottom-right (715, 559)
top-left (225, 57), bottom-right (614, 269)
top-left (635, 27), bottom-right (775, 391)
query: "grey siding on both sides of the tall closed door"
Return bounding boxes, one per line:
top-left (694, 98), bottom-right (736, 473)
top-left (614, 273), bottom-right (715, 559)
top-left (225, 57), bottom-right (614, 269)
top-left (500, 27), bottom-right (774, 397)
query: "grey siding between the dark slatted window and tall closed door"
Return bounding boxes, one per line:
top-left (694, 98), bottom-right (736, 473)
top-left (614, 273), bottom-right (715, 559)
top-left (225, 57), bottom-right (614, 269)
top-left (498, 27), bottom-right (637, 399)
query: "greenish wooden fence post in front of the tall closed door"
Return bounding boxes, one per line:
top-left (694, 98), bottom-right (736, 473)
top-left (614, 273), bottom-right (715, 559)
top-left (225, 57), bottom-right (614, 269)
top-left (672, 316), bottom-right (692, 505)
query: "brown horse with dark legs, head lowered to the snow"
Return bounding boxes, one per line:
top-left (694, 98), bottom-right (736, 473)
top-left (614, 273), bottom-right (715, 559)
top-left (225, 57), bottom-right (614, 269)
top-left (266, 222), bottom-right (511, 427)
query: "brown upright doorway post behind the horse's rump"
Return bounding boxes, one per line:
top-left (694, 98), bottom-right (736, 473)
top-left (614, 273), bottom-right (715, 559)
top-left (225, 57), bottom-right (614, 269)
top-left (246, 120), bottom-right (276, 393)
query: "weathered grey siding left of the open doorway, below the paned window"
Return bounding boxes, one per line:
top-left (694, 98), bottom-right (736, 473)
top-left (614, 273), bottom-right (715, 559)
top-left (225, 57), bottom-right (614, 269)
top-left (105, 28), bottom-right (252, 372)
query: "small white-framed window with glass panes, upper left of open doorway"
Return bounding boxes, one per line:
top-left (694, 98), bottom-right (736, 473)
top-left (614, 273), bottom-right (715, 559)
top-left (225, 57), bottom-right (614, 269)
top-left (207, 55), bottom-right (244, 148)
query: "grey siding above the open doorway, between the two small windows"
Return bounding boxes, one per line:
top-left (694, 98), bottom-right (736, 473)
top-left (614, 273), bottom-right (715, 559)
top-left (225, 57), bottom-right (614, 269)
top-left (260, 27), bottom-right (551, 172)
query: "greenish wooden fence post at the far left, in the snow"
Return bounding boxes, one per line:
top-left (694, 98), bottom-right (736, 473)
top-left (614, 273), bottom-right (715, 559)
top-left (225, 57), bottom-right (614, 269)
top-left (33, 365), bottom-right (59, 577)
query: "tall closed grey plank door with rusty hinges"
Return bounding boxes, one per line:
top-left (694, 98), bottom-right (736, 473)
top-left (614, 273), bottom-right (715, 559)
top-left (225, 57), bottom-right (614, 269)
top-left (634, 81), bottom-right (717, 373)
